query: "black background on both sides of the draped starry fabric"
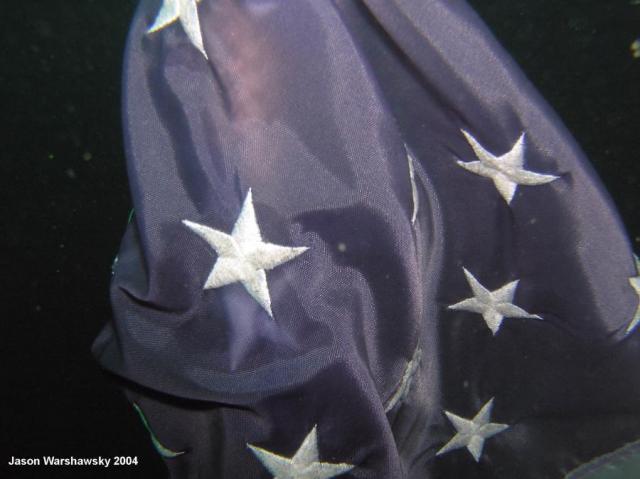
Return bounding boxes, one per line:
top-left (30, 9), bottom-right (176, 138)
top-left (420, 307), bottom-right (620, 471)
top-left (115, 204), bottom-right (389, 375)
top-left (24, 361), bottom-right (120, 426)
top-left (0, 0), bottom-right (640, 478)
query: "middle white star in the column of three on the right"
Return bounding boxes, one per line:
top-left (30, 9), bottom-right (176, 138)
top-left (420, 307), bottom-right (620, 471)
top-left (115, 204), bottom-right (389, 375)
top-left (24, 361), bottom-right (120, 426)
top-left (448, 268), bottom-right (542, 335)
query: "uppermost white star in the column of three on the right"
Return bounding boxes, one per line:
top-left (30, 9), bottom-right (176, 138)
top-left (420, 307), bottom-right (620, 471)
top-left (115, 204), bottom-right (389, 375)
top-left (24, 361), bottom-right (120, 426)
top-left (457, 130), bottom-right (558, 204)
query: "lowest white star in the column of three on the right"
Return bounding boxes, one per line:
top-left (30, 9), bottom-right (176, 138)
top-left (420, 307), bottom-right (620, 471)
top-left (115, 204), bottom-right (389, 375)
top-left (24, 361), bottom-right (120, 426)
top-left (436, 398), bottom-right (509, 462)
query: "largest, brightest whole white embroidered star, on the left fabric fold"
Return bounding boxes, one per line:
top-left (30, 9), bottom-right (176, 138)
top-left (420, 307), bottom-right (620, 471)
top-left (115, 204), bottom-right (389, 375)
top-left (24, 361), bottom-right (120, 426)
top-left (182, 190), bottom-right (309, 318)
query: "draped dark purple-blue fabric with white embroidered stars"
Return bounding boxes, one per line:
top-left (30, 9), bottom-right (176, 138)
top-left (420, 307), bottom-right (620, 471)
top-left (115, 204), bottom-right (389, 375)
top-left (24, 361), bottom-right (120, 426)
top-left (93, 0), bottom-right (640, 479)
